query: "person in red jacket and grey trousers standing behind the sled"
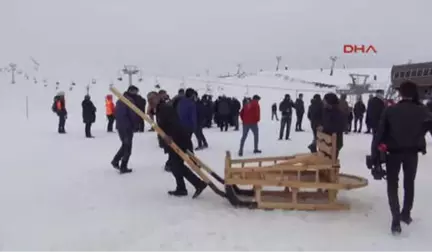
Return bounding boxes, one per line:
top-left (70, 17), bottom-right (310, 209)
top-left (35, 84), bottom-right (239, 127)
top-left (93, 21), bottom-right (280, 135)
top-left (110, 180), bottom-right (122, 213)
top-left (238, 95), bottom-right (261, 157)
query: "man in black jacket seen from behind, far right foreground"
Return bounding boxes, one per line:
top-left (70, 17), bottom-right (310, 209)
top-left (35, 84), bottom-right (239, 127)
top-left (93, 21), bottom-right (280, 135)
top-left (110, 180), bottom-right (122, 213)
top-left (371, 81), bottom-right (431, 234)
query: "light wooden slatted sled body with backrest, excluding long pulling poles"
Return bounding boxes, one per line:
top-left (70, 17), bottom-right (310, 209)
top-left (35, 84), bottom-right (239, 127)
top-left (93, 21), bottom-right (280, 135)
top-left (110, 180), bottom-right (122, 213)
top-left (225, 132), bottom-right (368, 210)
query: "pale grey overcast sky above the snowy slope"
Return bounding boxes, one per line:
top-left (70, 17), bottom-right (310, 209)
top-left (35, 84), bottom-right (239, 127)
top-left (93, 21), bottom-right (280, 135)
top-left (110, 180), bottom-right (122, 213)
top-left (0, 0), bottom-right (432, 78)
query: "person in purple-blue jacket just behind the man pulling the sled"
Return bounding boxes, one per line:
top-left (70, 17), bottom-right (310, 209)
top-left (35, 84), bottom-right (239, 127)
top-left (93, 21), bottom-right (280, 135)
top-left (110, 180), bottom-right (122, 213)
top-left (177, 88), bottom-right (198, 138)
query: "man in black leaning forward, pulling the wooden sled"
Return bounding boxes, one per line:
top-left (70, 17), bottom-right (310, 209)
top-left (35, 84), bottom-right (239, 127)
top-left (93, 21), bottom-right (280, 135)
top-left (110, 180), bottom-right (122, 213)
top-left (147, 92), bottom-right (207, 198)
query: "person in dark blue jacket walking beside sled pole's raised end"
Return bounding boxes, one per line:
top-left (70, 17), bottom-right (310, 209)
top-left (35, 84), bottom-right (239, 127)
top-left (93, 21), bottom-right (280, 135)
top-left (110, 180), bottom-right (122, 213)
top-left (111, 86), bottom-right (140, 174)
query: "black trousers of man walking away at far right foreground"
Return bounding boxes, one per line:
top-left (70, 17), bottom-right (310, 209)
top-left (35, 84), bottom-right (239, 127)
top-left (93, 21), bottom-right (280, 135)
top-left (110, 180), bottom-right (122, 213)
top-left (386, 152), bottom-right (418, 219)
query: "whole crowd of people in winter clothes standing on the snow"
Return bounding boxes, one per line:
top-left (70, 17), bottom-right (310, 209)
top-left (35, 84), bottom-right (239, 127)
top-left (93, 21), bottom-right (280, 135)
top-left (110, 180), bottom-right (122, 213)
top-left (52, 82), bottom-right (432, 233)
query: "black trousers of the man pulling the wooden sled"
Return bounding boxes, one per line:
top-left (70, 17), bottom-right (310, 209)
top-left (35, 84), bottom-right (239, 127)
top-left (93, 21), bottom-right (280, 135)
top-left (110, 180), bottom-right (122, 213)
top-left (167, 146), bottom-right (203, 191)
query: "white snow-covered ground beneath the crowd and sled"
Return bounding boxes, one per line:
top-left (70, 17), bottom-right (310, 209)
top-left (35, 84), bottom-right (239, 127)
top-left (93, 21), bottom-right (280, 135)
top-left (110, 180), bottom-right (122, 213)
top-left (0, 68), bottom-right (432, 252)
